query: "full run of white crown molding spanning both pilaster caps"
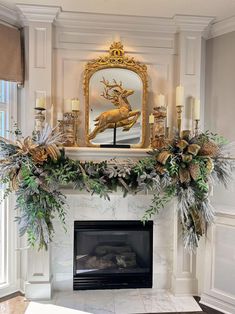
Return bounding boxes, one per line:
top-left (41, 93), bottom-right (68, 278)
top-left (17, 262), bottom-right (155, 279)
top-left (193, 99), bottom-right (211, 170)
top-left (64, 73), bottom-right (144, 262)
top-left (13, 4), bottom-right (214, 35)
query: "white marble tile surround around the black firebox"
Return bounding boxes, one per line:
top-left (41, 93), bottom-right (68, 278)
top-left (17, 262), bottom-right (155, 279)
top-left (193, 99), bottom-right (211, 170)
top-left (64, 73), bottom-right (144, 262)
top-left (51, 191), bottom-right (174, 291)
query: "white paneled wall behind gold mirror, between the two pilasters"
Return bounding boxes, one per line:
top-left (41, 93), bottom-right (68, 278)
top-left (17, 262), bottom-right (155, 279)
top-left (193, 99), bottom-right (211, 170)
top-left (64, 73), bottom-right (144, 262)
top-left (54, 21), bottom-right (174, 146)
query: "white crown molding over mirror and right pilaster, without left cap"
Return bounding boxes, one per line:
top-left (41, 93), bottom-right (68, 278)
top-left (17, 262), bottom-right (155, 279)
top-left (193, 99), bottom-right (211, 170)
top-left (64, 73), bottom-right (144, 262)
top-left (55, 12), bottom-right (214, 34)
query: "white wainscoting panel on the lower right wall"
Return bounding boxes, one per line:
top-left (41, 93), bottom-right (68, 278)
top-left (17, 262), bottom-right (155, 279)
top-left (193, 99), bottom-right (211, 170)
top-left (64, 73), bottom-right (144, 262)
top-left (201, 205), bottom-right (235, 314)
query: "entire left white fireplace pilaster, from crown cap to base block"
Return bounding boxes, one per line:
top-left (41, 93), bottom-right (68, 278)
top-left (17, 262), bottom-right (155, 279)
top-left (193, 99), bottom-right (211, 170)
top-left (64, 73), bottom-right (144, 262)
top-left (17, 4), bottom-right (60, 299)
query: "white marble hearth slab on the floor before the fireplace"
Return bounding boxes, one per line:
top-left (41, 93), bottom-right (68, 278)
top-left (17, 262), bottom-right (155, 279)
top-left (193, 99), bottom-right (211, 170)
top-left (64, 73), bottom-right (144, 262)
top-left (35, 289), bottom-right (202, 314)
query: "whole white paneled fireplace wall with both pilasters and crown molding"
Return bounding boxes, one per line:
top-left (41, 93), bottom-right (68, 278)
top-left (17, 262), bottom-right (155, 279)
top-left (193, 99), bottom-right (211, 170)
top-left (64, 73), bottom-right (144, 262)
top-left (18, 4), bottom-right (211, 298)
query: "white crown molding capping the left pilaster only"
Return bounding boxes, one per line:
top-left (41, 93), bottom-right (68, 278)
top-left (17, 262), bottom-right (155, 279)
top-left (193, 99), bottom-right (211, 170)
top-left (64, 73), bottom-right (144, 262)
top-left (16, 4), bottom-right (61, 25)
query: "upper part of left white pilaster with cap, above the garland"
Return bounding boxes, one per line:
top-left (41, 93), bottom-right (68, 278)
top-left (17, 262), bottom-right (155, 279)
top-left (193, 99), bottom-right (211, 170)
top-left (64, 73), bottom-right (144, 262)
top-left (17, 4), bottom-right (60, 135)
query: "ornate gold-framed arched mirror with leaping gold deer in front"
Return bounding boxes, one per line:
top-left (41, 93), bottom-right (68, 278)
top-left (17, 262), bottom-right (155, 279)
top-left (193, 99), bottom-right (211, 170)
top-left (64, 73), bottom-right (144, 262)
top-left (84, 42), bottom-right (147, 147)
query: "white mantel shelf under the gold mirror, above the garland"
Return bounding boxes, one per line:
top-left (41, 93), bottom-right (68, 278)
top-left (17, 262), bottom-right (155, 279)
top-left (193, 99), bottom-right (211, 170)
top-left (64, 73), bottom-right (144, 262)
top-left (65, 147), bottom-right (151, 161)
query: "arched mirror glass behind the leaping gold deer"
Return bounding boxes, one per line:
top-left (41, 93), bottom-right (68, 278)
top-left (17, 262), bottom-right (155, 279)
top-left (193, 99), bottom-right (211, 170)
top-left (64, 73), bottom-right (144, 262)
top-left (88, 67), bottom-right (143, 145)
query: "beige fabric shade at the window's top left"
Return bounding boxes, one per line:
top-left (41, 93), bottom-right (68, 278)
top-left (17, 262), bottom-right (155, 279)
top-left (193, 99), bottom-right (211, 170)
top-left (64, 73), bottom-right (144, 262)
top-left (0, 24), bottom-right (23, 83)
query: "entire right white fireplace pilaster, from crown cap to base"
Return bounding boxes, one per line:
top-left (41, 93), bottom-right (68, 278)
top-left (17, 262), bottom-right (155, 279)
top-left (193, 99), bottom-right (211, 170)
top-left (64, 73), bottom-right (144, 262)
top-left (172, 15), bottom-right (212, 295)
